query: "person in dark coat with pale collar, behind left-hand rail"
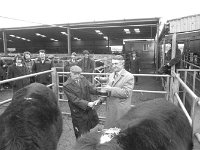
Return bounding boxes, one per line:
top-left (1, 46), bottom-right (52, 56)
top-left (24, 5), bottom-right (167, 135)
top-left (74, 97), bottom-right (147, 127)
top-left (7, 55), bottom-right (30, 93)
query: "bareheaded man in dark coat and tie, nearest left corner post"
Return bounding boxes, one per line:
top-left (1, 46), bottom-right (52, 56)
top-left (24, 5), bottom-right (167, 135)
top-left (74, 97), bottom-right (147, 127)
top-left (32, 50), bottom-right (53, 85)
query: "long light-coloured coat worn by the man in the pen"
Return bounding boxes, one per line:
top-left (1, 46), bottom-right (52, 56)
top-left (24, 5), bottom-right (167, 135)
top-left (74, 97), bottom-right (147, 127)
top-left (104, 69), bottom-right (134, 129)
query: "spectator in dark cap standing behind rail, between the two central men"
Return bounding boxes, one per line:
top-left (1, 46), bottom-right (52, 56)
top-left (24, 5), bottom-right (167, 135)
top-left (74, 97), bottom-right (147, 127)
top-left (78, 50), bottom-right (94, 82)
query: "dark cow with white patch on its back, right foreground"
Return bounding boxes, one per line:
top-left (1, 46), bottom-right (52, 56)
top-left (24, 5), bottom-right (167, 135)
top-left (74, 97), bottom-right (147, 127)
top-left (74, 99), bottom-right (192, 150)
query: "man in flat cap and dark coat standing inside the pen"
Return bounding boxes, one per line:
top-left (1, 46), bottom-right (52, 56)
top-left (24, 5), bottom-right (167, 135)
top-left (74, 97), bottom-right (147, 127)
top-left (63, 65), bottom-right (105, 138)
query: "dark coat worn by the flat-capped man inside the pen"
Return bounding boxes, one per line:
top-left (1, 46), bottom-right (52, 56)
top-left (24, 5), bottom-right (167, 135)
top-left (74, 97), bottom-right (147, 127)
top-left (63, 76), bottom-right (99, 128)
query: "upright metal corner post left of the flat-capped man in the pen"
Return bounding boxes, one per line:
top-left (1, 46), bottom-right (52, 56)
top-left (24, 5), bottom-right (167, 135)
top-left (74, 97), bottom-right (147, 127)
top-left (51, 67), bottom-right (59, 101)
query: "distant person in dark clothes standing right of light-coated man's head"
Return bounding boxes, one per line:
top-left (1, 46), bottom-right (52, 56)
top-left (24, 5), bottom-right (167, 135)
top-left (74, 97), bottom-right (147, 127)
top-left (130, 51), bottom-right (140, 84)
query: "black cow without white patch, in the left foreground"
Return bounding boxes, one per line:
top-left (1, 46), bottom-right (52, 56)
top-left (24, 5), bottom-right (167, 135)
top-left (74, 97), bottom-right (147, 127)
top-left (0, 83), bottom-right (62, 150)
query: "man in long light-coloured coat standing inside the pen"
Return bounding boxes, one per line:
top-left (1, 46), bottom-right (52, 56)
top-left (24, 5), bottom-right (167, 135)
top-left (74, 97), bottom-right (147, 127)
top-left (100, 55), bottom-right (134, 129)
